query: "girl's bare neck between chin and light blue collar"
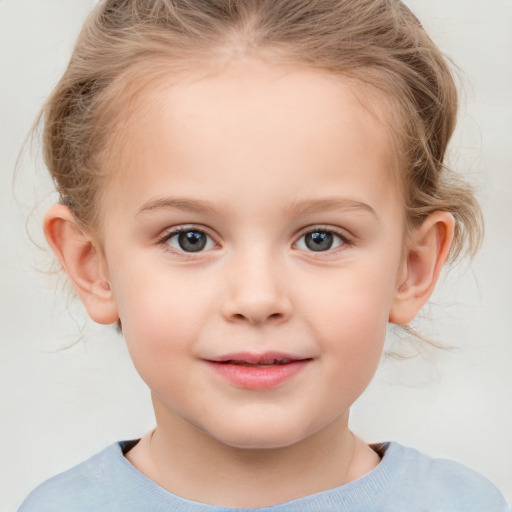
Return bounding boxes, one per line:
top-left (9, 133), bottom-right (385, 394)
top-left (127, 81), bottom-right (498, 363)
top-left (127, 402), bottom-right (379, 508)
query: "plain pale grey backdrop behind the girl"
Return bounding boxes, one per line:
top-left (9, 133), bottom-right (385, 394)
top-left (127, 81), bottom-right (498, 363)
top-left (0, 0), bottom-right (512, 512)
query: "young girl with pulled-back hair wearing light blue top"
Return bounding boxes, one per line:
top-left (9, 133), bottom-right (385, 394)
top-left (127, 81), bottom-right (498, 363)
top-left (16, 0), bottom-right (508, 512)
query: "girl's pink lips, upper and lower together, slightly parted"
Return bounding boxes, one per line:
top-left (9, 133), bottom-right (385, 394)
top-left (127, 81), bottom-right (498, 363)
top-left (204, 352), bottom-right (312, 390)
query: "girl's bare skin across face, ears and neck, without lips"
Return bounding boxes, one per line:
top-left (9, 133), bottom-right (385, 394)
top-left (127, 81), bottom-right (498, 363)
top-left (45, 60), bottom-right (453, 507)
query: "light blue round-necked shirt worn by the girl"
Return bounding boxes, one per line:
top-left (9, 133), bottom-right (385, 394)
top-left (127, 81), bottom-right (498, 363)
top-left (18, 441), bottom-right (510, 512)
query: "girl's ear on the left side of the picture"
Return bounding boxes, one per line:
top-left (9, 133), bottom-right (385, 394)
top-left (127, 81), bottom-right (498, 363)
top-left (44, 204), bottom-right (119, 324)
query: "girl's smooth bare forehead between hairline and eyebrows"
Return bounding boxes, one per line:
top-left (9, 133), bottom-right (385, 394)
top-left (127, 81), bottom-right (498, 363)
top-left (100, 61), bottom-right (402, 220)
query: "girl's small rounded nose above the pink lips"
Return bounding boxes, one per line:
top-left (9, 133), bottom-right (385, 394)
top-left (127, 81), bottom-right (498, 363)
top-left (222, 248), bottom-right (292, 325)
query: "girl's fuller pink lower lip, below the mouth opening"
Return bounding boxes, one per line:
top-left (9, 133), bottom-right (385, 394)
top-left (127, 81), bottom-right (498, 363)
top-left (206, 359), bottom-right (311, 390)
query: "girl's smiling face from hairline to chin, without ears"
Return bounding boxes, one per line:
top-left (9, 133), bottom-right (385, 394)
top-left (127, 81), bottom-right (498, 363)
top-left (98, 61), bottom-right (404, 448)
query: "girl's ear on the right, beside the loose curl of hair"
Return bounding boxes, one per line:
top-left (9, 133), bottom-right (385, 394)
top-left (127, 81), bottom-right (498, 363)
top-left (389, 211), bottom-right (455, 325)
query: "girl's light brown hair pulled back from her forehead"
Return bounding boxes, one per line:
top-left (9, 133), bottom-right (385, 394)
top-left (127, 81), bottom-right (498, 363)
top-left (42, 0), bottom-right (482, 258)
